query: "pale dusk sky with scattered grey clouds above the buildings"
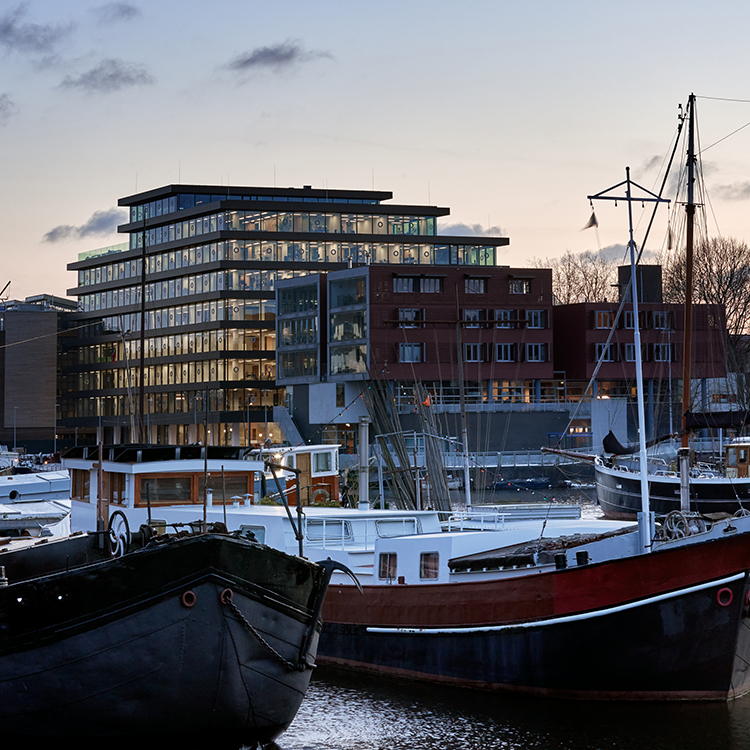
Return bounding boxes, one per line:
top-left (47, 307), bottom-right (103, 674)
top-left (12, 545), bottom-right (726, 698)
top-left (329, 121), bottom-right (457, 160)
top-left (0, 0), bottom-right (750, 299)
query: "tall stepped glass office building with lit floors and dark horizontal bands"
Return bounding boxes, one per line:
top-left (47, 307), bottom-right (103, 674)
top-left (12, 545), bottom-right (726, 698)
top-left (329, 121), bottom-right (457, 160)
top-left (60, 185), bottom-right (509, 446)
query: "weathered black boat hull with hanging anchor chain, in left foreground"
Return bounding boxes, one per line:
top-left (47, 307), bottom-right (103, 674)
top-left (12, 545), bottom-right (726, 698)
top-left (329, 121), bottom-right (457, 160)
top-left (0, 536), bottom-right (322, 743)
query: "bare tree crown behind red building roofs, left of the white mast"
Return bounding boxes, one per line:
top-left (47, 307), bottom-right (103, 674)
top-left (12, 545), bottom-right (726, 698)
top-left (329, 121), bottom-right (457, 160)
top-left (529, 250), bottom-right (617, 305)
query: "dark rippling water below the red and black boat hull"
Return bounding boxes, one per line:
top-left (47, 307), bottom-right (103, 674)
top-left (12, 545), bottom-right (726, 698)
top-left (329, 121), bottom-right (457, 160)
top-left (278, 668), bottom-right (750, 750)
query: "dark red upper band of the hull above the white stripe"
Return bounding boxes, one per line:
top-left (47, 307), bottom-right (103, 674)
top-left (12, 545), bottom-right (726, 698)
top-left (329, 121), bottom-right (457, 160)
top-left (323, 535), bottom-right (750, 627)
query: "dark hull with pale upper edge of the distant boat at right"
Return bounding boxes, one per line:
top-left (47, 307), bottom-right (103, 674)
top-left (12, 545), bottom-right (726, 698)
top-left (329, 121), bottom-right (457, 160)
top-left (595, 465), bottom-right (750, 520)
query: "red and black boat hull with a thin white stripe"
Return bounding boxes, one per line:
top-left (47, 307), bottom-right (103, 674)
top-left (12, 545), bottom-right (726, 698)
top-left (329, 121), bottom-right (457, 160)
top-left (319, 537), bottom-right (750, 700)
